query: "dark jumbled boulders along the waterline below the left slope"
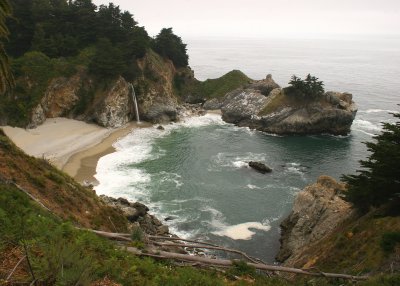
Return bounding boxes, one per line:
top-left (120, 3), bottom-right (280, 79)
top-left (100, 195), bottom-right (169, 235)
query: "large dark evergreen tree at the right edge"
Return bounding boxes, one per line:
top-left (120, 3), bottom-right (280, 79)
top-left (342, 110), bottom-right (400, 212)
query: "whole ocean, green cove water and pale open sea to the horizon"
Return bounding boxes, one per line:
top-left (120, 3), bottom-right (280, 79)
top-left (96, 37), bottom-right (400, 262)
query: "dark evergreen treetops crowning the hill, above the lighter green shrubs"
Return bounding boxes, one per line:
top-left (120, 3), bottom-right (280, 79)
top-left (6, 0), bottom-right (188, 80)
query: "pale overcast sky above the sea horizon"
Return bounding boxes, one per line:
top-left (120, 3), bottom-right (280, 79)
top-left (93, 0), bottom-right (400, 37)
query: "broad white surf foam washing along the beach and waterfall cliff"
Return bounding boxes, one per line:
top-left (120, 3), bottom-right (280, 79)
top-left (95, 114), bottom-right (226, 200)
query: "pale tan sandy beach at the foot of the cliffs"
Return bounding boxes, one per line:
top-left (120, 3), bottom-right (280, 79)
top-left (0, 118), bottom-right (151, 183)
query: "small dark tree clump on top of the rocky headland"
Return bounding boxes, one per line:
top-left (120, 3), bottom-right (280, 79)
top-left (284, 74), bottom-right (325, 99)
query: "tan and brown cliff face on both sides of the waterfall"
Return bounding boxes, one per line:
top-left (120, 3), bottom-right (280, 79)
top-left (28, 51), bottom-right (189, 128)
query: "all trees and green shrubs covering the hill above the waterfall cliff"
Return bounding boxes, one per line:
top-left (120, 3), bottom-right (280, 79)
top-left (0, 0), bottom-right (188, 127)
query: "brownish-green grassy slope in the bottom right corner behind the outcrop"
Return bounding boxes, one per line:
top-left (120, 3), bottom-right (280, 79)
top-left (288, 211), bottom-right (400, 285)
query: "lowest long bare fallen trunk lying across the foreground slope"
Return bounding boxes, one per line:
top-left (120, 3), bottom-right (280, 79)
top-left (125, 247), bottom-right (368, 280)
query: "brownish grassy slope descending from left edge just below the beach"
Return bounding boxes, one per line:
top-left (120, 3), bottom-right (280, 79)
top-left (0, 130), bottom-right (127, 231)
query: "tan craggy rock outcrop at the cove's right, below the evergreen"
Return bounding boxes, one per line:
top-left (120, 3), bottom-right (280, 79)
top-left (276, 176), bottom-right (352, 265)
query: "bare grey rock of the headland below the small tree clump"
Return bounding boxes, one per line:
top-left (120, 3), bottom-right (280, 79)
top-left (217, 75), bottom-right (357, 135)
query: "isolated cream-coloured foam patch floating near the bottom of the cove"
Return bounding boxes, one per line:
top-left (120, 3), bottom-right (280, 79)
top-left (213, 222), bottom-right (271, 240)
